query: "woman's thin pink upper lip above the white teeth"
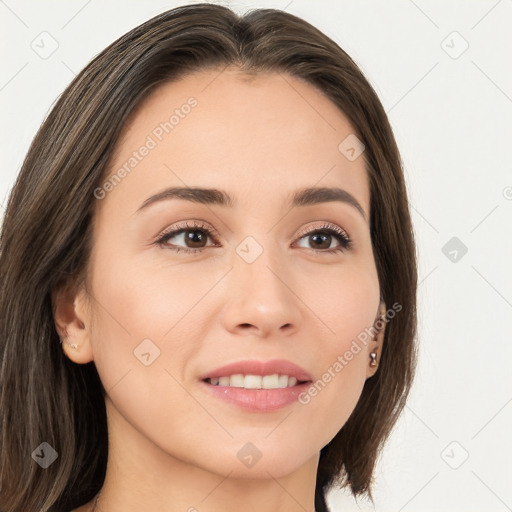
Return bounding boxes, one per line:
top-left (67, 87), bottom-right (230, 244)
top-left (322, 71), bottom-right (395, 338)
top-left (200, 359), bottom-right (312, 381)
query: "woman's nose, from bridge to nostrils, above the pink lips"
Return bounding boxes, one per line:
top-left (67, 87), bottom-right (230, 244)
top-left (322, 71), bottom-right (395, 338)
top-left (222, 244), bottom-right (304, 338)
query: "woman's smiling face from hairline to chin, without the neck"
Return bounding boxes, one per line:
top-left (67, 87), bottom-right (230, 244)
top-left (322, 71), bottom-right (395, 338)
top-left (65, 68), bottom-right (380, 478)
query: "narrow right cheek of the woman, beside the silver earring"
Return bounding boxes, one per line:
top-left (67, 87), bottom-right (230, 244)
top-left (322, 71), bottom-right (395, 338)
top-left (299, 268), bottom-right (380, 443)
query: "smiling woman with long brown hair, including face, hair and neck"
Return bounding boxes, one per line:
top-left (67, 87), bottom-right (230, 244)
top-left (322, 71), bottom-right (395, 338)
top-left (0, 4), bottom-right (416, 512)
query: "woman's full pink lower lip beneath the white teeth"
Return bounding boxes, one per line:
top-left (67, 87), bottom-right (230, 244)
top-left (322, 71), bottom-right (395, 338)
top-left (201, 381), bottom-right (311, 412)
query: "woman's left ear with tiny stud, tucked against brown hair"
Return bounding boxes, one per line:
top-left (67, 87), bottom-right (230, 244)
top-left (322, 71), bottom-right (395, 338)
top-left (52, 283), bottom-right (94, 364)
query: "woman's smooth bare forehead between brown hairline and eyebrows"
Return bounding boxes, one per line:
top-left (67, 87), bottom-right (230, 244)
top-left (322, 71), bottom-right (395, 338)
top-left (98, 67), bottom-right (369, 216)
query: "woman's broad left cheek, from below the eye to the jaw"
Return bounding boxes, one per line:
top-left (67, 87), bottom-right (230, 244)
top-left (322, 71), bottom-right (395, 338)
top-left (88, 253), bottom-right (222, 452)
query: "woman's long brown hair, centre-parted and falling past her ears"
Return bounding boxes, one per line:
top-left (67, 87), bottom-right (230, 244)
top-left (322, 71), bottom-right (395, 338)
top-left (0, 4), bottom-right (417, 512)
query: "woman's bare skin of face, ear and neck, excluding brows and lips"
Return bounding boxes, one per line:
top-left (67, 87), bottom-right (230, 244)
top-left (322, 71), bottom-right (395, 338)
top-left (54, 68), bottom-right (383, 512)
